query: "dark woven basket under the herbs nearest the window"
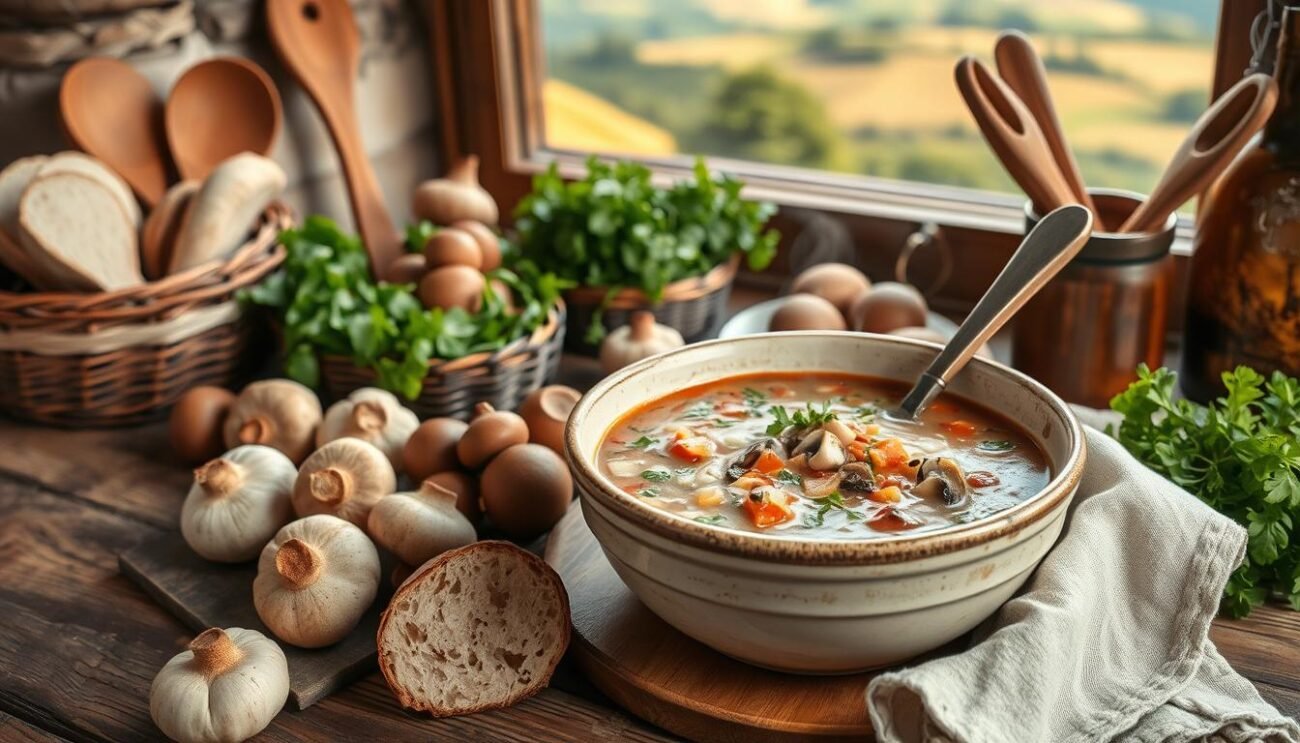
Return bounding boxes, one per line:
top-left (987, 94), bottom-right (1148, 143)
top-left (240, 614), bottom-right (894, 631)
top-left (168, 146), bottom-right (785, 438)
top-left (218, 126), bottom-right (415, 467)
top-left (564, 256), bottom-right (740, 356)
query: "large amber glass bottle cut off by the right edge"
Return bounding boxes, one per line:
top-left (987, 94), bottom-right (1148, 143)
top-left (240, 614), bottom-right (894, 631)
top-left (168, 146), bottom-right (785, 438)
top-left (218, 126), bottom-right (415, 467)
top-left (1179, 8), bottom-right (1300, 401)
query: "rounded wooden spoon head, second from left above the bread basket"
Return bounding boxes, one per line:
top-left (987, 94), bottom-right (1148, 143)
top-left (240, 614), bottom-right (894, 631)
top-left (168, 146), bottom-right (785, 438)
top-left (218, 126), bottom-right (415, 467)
top-left (165, 57), bottom-right (282, 181)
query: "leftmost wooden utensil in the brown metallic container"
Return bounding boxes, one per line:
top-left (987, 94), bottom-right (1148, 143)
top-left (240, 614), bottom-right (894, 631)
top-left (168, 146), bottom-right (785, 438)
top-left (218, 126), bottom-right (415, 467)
top-left (956, 56), bottom-right (1075, 214)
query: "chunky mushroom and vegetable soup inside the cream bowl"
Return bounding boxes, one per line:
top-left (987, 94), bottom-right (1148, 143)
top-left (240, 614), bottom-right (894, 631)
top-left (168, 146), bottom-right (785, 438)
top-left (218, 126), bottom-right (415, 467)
top-left (599, 374), bottom-right (1048, 539)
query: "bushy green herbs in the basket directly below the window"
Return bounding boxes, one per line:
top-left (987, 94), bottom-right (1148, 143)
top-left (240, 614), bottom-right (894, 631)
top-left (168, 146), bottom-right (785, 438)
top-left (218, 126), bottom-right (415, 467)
top-left (515, 157), bottom-right (779, 342)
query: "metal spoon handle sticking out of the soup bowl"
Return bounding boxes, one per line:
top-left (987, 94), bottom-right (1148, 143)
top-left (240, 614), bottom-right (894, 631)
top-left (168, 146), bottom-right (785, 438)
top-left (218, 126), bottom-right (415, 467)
top-left (900, 204), bottom-right (1092, 418)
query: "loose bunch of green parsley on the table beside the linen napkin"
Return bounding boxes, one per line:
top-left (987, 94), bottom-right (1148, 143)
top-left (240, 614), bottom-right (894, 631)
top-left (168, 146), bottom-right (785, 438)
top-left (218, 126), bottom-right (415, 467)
top-left (1108, 365), bottom-right (1300, 617)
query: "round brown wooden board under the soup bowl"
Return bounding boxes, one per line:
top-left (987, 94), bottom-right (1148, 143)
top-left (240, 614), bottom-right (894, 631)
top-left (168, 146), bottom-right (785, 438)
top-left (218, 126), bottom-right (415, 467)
top-left (546, 501), bottom-right (872, 742)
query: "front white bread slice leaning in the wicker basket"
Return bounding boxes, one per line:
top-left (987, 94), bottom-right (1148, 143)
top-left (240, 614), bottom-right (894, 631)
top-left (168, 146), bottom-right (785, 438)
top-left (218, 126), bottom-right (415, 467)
top-left (18, 173), bottom-right (144, 291)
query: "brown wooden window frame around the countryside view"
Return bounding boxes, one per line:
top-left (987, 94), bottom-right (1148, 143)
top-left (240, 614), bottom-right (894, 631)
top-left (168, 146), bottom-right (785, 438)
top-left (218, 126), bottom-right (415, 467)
top-left (428, 0), bottom-right (1270, 323)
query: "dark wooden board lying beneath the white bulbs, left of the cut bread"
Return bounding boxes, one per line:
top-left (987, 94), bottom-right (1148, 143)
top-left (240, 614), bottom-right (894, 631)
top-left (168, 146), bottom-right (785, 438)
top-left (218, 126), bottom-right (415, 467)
top-left (117, 531), bottom-right (391, 709)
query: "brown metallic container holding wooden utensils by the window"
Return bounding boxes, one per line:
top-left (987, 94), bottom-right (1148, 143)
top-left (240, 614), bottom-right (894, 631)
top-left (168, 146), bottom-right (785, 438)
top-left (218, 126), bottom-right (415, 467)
top-left (1011, 188), bottom-right (1178, 408)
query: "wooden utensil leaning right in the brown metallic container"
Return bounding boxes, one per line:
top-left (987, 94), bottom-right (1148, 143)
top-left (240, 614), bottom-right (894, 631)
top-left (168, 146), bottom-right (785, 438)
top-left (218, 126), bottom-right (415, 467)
top-left (1119, 73), bottom-right (1278, 233)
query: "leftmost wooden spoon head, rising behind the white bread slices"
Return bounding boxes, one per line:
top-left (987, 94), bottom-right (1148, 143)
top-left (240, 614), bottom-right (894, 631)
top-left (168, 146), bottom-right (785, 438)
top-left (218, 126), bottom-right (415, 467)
top-left (59, 57), bottom-right (168, 208)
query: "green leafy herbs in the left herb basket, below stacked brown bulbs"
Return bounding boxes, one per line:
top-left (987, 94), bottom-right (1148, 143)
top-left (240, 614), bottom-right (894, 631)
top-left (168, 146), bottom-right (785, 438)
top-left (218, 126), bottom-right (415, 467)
top-left (244, 217), bottom-right (568, 400)
